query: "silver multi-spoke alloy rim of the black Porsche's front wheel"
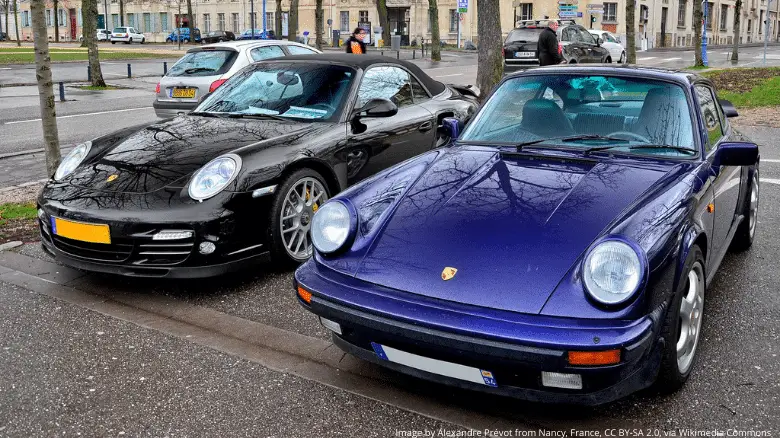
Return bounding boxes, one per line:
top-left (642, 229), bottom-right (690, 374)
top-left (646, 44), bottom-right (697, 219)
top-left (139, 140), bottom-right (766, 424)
top-left (279, 177), bottom-right (328, 261)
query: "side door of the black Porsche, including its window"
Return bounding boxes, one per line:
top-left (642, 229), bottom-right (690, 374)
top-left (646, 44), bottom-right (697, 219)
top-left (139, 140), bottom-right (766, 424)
top-left (347, 65), bottom-right (436, 184)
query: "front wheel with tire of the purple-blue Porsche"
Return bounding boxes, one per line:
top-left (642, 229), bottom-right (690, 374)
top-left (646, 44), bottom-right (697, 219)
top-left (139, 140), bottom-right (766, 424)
top-left (655, 245), bottom-right (706, 394)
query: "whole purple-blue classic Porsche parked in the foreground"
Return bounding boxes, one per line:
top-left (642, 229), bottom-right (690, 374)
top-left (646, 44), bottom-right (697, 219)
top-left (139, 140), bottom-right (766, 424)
top-left (294, 66), bottom-right (760, 409)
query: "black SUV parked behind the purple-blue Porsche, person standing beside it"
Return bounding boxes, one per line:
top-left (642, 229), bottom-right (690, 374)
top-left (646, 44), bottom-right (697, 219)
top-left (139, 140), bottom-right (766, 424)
top-left (502, 20), bottom-right (612, 72)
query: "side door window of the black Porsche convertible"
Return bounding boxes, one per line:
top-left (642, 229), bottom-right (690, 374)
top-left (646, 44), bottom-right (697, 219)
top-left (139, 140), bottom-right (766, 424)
top-left (357, 67), bottom-right (413, 108)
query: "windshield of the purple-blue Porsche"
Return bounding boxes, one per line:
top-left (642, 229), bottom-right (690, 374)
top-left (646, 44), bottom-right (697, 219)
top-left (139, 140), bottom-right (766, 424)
top-left (459, 74), bottom-right (697, 157)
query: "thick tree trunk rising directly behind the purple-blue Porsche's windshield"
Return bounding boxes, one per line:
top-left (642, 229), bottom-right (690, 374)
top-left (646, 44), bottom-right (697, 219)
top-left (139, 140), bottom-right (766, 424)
top-left (472, 0), bottom-right (504, 100)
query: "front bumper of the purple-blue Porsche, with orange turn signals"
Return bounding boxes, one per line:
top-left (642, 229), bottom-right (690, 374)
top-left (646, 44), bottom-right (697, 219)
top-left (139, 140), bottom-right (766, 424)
top-left (295, 260), bottom-right (665, 405)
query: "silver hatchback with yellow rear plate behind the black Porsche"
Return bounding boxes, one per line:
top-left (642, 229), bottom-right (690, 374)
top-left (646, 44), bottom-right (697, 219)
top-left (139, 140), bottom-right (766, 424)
top-left (153, 40), bottom-right (321, 117)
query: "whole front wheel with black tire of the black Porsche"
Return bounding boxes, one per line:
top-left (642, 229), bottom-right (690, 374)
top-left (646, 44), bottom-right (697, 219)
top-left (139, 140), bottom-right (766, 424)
top-left (268, 168), bottom-right (331, 266)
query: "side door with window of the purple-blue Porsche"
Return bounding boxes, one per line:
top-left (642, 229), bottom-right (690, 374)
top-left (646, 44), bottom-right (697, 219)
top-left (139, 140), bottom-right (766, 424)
top-left (694, 84), bottom-right (742, 263)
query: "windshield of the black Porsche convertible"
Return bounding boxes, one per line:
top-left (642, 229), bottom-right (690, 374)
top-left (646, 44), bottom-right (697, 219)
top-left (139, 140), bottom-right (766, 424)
top-left (195, 62), bottom-right (355, 121)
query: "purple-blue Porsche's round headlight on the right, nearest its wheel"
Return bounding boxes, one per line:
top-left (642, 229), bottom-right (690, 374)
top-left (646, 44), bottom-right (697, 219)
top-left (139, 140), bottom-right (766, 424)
top-left (582, 240), bottom-right (642, 304)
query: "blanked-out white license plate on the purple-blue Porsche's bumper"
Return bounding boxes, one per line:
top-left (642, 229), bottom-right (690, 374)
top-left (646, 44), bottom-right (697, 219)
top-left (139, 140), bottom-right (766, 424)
top-left (371, 342), bottom-right (498, 387)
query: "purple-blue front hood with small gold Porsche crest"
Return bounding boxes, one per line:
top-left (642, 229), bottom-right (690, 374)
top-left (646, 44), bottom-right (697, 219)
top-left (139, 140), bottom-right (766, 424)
top-left (356, 148), bottom-right (670, 314)
